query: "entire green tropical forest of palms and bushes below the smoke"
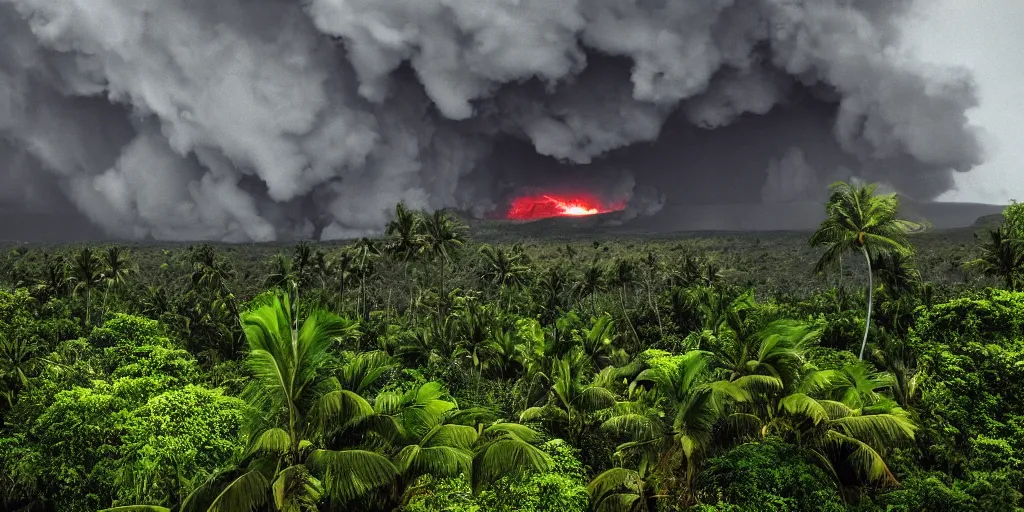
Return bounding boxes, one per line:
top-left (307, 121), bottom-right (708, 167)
top-left (0, 182), bottom-right (1024, 512)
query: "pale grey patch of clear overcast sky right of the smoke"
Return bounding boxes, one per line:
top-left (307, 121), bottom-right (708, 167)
top-left (907, 0), bottom-right (1024, 203)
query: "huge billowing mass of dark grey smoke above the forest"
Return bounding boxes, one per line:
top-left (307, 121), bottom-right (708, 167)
top-left (0, 0), bottom-right (982, 241)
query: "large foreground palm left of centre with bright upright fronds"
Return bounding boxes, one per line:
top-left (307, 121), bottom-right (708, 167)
top-left (210, 295), bottom-right (397, 511)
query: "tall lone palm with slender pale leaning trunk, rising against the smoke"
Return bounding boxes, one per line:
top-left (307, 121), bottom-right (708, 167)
top-left (810, 181), bottom-right (912, 359)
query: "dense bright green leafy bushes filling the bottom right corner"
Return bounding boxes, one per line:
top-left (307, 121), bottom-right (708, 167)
top-left (910, 291), bottom-right (1024, 510)
